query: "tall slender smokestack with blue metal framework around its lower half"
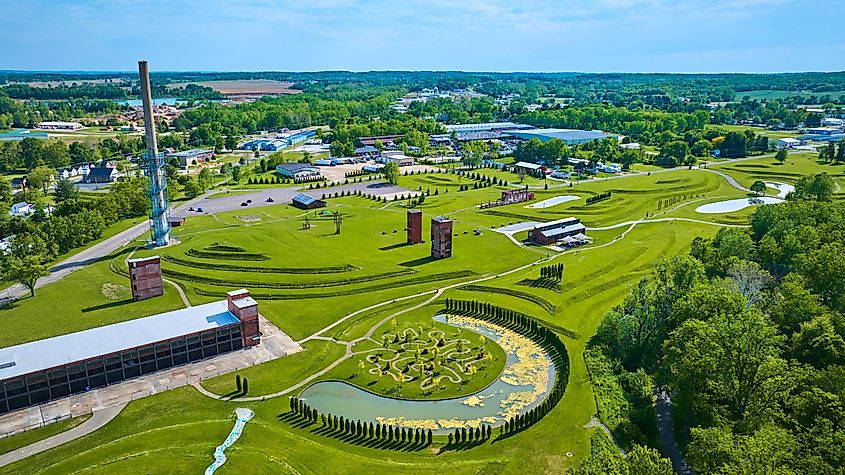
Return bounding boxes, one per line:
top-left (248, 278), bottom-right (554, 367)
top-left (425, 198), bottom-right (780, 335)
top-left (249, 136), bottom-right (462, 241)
top-left (138, 61), bottom-right (170, 246)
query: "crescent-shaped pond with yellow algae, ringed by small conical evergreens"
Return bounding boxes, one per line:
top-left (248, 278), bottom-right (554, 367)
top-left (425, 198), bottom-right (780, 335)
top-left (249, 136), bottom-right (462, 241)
top-left (299, 315), bottom-right (555, 434)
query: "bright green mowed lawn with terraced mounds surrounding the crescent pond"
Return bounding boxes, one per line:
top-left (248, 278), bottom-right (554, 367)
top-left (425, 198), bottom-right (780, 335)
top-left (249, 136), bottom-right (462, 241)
top-left (0, 156), bottom-right (832, 474)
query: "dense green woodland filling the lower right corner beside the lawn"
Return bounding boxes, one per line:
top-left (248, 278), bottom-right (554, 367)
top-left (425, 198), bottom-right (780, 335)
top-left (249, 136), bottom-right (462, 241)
top-left (588, 196), bottom-right (845, 474)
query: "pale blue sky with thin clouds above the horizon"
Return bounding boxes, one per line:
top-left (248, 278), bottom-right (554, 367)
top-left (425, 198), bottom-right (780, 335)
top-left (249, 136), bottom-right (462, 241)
top-left (0, 0), bottom-right (845, 72)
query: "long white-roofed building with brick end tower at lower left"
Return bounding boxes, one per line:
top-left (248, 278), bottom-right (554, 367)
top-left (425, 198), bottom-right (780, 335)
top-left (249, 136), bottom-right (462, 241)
top-left (0, 289), bottom-right (261, 413)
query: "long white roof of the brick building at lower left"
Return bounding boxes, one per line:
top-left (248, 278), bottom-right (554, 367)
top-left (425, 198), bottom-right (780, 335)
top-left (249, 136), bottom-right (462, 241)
top-left (0, 300), bottom-right (238, 381)
